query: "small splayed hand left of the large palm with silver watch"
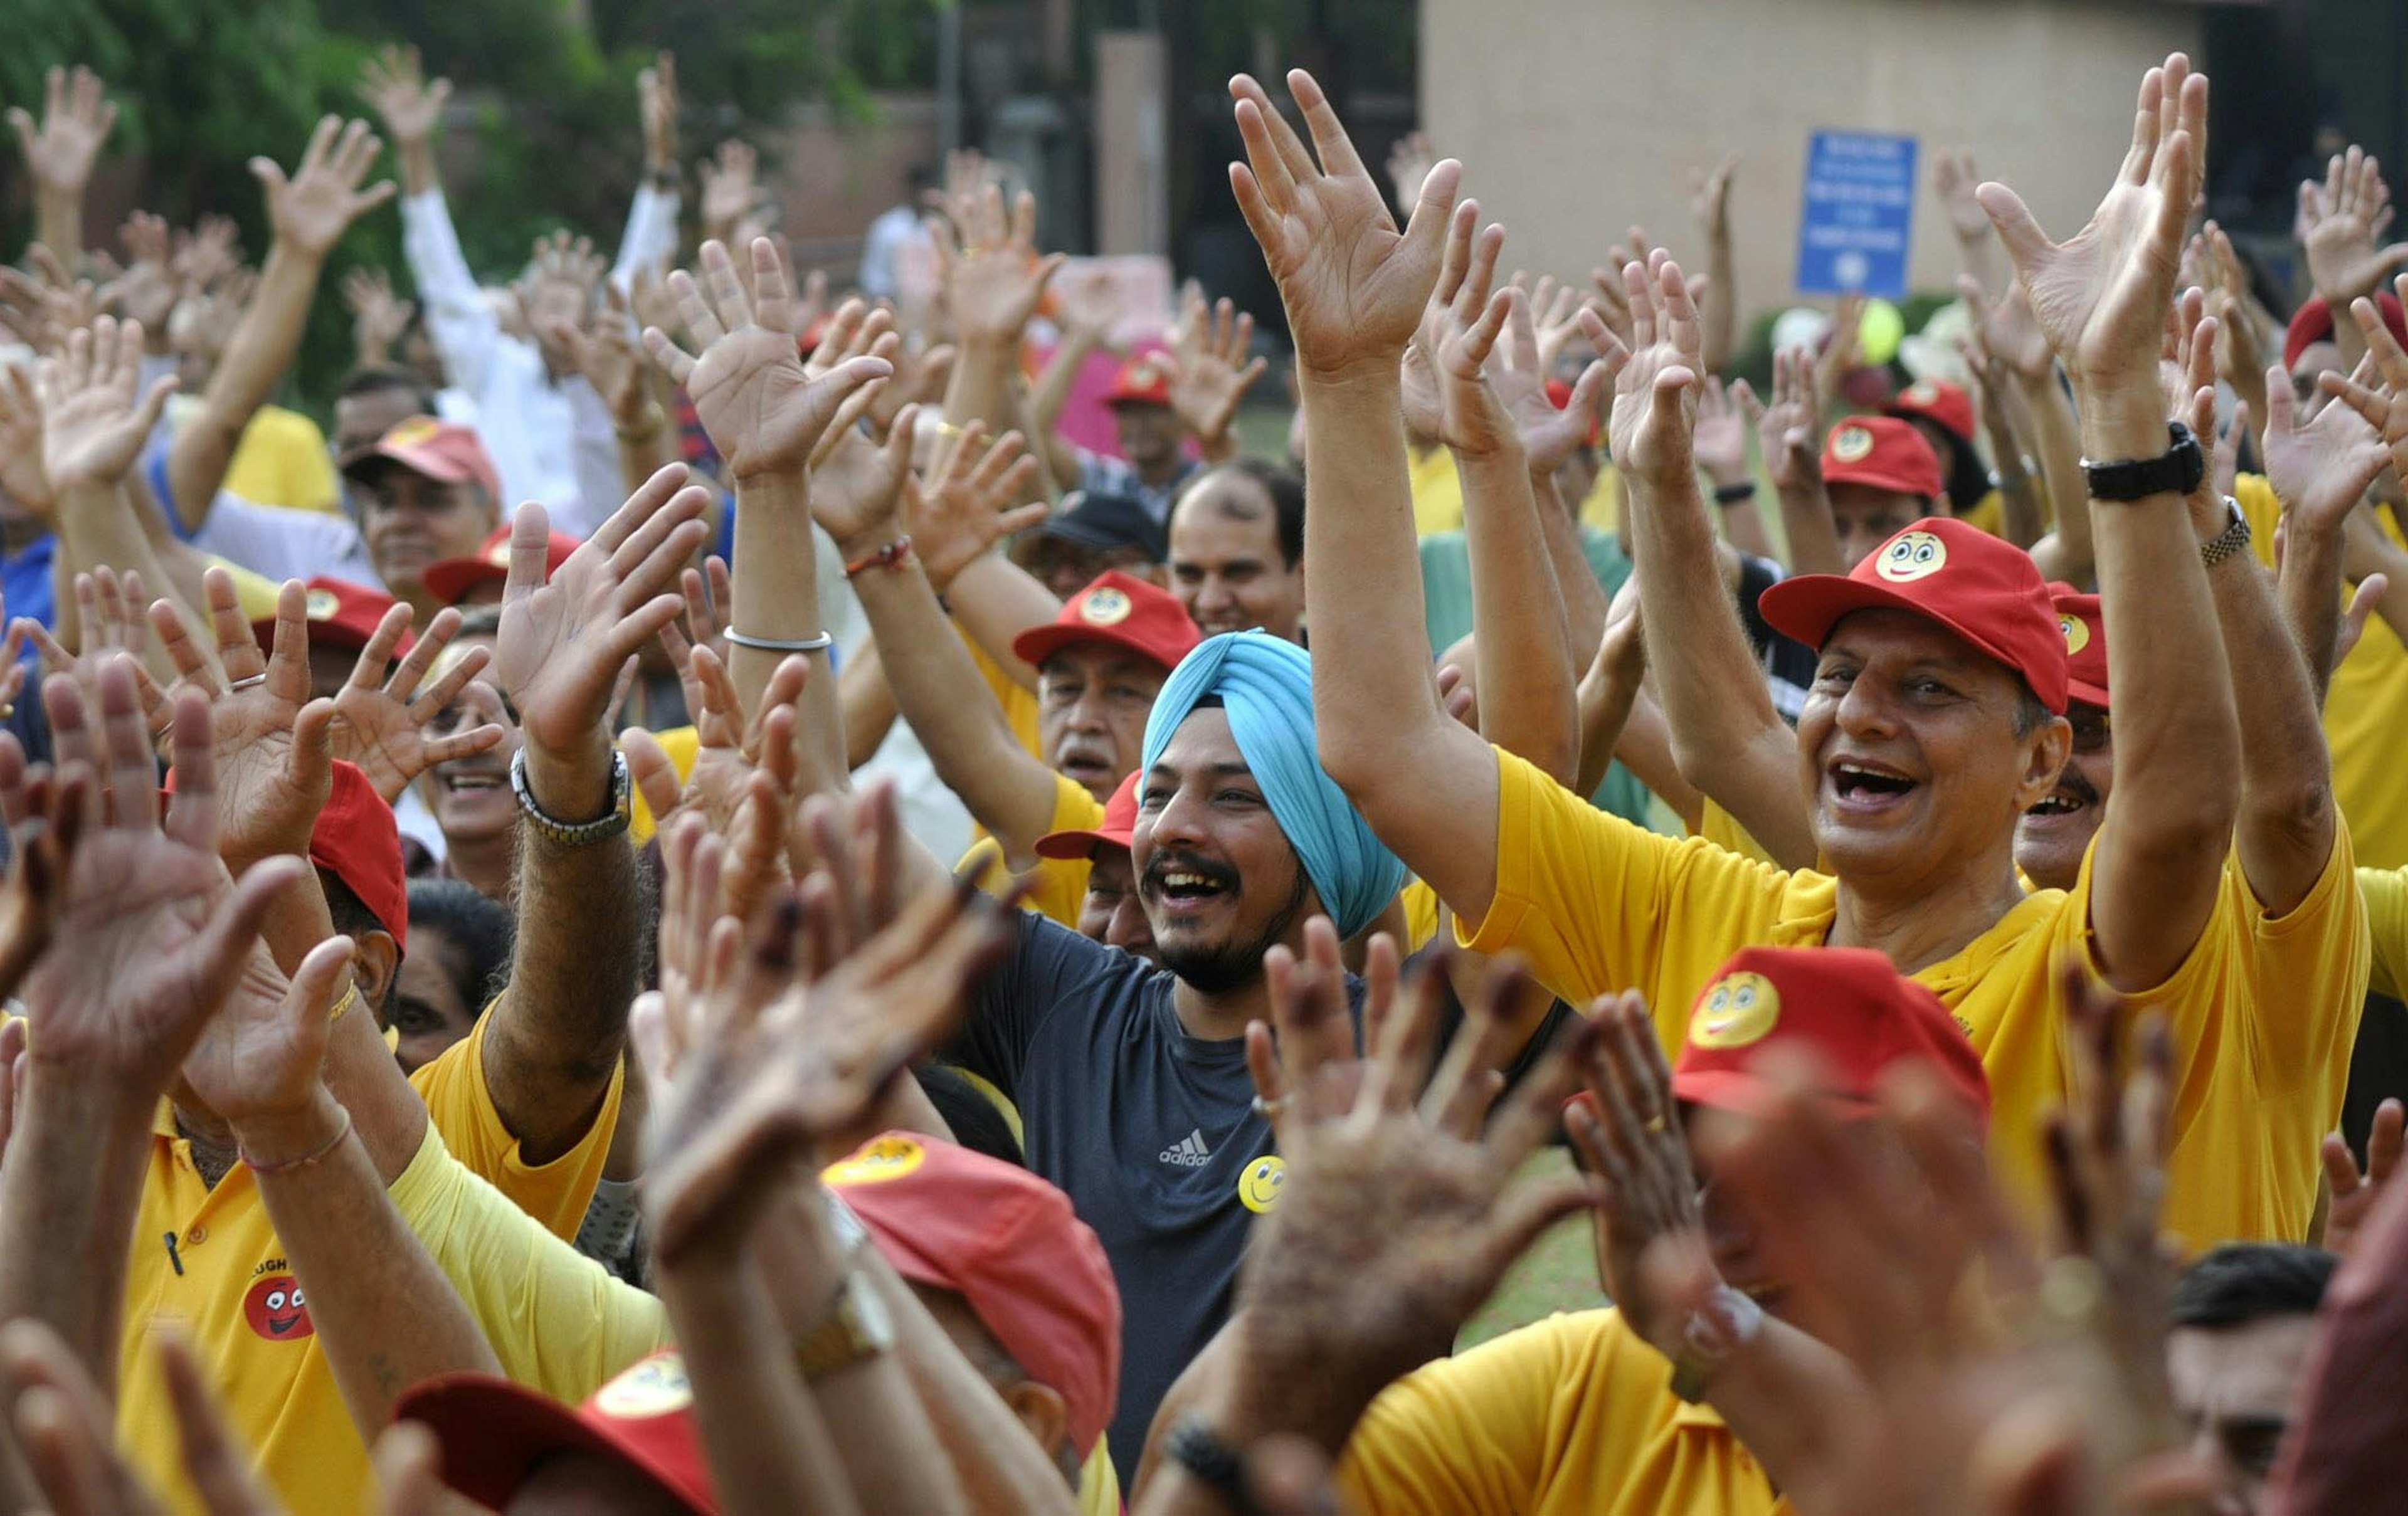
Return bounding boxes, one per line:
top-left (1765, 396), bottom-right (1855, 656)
top-left (335, 604), bottom-right (501, 806)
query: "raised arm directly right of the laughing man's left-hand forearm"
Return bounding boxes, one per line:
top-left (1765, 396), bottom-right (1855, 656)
top-left (1406, 220), bottom-right (1603, 782)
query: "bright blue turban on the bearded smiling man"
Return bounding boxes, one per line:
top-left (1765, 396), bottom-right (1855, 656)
top-left (1144, 631), bottom-right (1407, 936)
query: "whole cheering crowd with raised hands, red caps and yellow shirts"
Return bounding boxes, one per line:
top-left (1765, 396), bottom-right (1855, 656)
top-left (0, 35), bottom-right (2408, 1516)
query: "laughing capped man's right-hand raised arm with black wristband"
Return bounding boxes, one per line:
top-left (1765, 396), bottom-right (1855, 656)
top-left (1982, 53), bottom-right (2239, 991)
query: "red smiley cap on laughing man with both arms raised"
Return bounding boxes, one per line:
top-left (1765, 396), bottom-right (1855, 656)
top-left (1755, 520), bottom-right (2066, 715)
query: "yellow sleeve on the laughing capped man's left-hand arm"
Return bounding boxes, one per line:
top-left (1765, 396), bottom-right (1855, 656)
top-left (1454, 749), bottom-right (1787, 1006)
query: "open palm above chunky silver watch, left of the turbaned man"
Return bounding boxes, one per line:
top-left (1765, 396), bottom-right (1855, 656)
top-left (494, 471), bottom-right (703, 784)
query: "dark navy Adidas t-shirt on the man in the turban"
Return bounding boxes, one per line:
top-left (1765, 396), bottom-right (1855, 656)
top-left (954, 912), bottom-right (1329, 1478)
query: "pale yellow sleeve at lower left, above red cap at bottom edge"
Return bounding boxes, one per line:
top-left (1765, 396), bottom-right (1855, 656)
top-left (388, 1124), bottom-right (670, 1405)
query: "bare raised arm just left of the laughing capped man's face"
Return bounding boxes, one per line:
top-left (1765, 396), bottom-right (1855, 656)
top-left (1611, 258), bottom-right (1814, 856)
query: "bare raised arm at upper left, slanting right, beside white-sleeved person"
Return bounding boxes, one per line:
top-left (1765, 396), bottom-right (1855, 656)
top-left (166, 115), bottom-right (393, 529)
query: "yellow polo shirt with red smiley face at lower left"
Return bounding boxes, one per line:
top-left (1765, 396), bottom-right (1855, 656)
top-left (118, 1016), bottom-right (640, 1511)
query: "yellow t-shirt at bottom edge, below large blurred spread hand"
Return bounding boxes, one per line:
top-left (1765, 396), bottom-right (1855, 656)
top-left (1336, 1309), bottom-right (1789, 1516)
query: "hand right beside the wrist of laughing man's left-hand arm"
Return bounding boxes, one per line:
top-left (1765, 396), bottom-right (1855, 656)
top-left (1404, 200), bottom-right (1522, 457)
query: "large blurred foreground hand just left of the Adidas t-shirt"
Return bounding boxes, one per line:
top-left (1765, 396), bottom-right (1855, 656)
top-left (636, 828), bottom-right (1009, 1263)
